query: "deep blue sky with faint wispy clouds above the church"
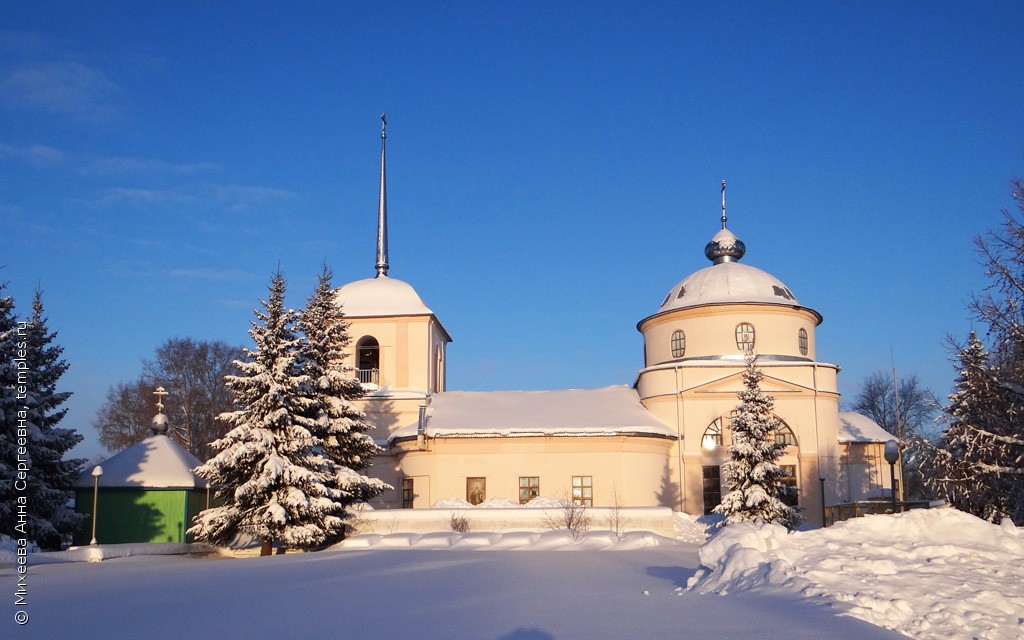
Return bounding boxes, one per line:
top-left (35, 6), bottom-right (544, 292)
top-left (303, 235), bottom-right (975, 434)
top-left (0, 2), bottom-right (1024, 456)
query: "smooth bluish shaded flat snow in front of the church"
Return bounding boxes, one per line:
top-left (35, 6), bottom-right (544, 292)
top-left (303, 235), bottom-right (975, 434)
top-left (12, 542), bottom-right (902, 640)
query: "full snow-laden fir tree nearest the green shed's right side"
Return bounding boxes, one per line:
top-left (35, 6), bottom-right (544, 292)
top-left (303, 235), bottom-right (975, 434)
top-left (189, 272), bottom-right (345, 555)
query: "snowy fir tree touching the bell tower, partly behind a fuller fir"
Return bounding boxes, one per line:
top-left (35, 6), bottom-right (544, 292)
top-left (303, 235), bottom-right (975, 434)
top-left (297, 265), bottom-right (391, 532)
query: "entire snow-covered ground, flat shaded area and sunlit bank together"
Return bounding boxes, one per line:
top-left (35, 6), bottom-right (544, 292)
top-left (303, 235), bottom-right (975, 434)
top-left (0, 510), bottom-right (1024, 640)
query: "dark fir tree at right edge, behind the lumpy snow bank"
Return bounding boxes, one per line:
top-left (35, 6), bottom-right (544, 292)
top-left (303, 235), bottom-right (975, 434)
top-left (923, 332), bottom-right (1024, 524)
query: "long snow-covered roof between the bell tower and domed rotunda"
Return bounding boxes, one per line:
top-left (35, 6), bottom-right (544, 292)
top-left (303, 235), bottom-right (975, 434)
top-left (391, 385), bottom-right (675, 440)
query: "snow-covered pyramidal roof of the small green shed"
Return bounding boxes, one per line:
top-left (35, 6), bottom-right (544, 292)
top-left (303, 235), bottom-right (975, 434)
top-left (75, 435), bottom-right (207, 488)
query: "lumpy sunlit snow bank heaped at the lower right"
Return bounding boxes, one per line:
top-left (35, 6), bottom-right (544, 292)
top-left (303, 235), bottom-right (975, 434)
top-left (687, 509), bottom-right (1024, 640)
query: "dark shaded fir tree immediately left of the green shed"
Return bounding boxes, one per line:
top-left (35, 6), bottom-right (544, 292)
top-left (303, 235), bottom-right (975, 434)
top-left (24, 291), bottom-right (85, 549)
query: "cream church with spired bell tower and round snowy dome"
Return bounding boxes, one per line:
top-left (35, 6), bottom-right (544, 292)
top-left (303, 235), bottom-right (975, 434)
top-left (336, 118), bottom-right (892, 523)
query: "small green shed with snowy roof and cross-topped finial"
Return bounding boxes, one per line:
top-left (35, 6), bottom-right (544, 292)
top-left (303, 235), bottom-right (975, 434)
top-left (75, 413), bottom-right (210, 545)
